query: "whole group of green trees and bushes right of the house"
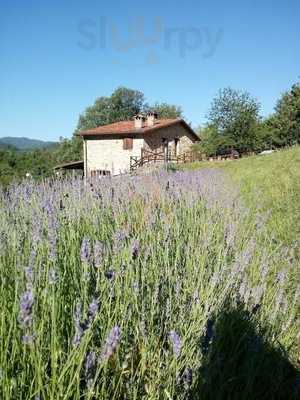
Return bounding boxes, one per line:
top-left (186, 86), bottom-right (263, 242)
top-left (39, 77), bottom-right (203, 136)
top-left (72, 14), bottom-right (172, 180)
top-left (198, 84), bottom-right (300, 155)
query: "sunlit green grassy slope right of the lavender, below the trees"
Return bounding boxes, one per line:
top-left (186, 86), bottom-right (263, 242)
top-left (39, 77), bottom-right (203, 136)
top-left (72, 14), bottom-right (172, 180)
top-left (184, 147), bottom-right (300, 254)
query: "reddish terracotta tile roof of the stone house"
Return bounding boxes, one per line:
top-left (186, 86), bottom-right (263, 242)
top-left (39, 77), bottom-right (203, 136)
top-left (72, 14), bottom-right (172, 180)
top-left (79, 118), bottom-right (198, 139)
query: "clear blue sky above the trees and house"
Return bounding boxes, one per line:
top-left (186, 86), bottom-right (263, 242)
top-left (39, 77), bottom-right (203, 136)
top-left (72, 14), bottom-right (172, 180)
top-left (0, 0), bottom-right (300, 140)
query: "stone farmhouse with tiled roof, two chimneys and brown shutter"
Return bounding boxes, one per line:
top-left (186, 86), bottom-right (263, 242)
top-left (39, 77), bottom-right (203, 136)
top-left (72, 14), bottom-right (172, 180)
top-left (79, 113), bottom-right (199, 177)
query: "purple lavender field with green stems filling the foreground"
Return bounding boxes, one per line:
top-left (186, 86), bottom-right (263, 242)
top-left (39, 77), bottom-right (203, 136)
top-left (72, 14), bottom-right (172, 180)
top-left (0, 169), bottom-right (300, 400)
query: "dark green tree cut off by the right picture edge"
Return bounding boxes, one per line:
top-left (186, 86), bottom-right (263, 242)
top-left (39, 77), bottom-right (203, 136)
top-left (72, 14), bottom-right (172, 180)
top-left (269, 83), bottom-right (300, 146)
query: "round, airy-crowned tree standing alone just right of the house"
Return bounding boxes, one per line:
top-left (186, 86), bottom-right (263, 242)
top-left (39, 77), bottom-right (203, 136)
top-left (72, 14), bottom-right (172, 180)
top-left (208, 88), bottom-right (260, 152)
